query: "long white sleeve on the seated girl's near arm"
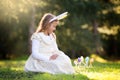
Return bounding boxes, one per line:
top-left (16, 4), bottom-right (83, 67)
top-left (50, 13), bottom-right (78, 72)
top-left (32, 39), bottom-right (49, 61)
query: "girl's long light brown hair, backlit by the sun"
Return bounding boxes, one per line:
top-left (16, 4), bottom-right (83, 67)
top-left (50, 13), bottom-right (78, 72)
top-left (36, 13), bottom-right (55, 33)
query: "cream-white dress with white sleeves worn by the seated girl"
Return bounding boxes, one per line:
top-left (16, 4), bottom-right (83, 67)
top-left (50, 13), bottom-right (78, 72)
top-left (25, 32), bottom-right (74, 74)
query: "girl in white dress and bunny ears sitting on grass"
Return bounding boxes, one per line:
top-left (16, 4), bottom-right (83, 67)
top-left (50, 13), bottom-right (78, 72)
top-left (25, 13), bottom-right (74, 74)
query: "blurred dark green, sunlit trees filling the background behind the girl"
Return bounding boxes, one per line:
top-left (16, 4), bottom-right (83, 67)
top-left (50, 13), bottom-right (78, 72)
top-left (0, 0), bottom-right (120, 60)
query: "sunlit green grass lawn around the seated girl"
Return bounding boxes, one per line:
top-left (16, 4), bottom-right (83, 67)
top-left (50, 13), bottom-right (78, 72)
top-left (0, 57), bottom-right (120, 80)
